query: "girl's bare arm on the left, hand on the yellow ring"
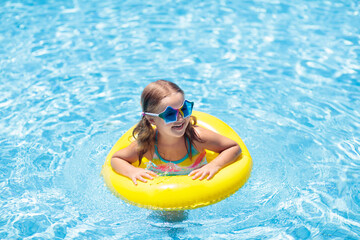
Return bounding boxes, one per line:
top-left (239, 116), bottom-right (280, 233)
top-left (111, 142), bottom-right (157, 185)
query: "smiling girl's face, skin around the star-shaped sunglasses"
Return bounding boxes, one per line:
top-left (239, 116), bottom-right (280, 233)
top-left (151, 93), bottom-right (190, 137)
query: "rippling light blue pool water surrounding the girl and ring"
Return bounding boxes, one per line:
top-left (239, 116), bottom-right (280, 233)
top-left (0, 0), bottom-right (360, 239)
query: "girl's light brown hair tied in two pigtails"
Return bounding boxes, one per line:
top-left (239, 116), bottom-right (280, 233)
top-left (133, 80), bottom-right (202, 165)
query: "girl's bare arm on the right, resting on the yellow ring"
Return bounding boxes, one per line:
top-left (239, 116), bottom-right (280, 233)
top-left (189, 127), bottom-right (241, 180)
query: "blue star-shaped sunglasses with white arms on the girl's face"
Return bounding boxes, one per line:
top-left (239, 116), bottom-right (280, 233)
top-left (142, 100), bottom-right (194, 124)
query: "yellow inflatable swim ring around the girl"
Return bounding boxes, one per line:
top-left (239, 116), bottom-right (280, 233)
top-left (102, 111), bottom-right (252, 211)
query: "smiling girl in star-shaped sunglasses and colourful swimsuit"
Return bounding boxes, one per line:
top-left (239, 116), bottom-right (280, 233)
top-left (111, 80), bottom-right (241, 185)
